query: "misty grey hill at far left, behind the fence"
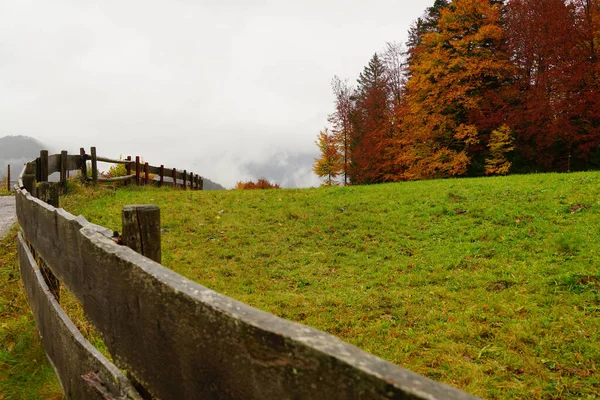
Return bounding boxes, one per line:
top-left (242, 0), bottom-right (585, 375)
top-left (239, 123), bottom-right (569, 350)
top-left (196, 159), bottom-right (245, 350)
top-left (0, 136), bottom-right (47, 179)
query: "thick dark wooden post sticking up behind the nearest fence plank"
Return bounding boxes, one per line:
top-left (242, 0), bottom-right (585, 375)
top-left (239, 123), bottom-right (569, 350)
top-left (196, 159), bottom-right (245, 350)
top-left (121, 204), bottom-right (161, 263)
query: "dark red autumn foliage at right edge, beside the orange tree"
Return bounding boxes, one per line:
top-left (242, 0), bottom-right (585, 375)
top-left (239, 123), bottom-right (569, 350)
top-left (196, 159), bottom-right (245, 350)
top-left (506, 0), bottom-right (600, 170)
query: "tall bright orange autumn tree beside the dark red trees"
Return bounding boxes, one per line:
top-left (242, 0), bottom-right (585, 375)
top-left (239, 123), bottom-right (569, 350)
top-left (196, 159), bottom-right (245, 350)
top-left (394, 0), bottom-right (511, 179)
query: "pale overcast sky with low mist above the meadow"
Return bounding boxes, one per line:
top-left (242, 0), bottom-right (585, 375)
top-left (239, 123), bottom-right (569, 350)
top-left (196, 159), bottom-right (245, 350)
top-left (0, 0), bottom-right (433, 188)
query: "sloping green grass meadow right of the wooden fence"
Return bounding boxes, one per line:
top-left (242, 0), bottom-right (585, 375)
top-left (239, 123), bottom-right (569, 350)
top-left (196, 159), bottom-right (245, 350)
top-left (1, 172), bottom-right (600, 399)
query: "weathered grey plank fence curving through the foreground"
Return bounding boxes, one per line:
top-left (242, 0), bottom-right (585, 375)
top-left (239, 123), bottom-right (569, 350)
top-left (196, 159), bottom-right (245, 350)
top-left (15, 151), bottom-right (473, 399)
